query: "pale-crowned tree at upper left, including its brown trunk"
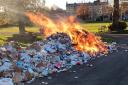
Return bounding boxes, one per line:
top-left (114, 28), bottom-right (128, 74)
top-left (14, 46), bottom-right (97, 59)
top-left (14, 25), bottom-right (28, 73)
top-left (0, 0), bottom-right (45, 34)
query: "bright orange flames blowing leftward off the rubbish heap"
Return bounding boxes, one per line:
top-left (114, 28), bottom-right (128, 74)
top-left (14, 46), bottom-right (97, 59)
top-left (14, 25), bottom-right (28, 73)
top-left (26, 13), bottom-right (107, 55)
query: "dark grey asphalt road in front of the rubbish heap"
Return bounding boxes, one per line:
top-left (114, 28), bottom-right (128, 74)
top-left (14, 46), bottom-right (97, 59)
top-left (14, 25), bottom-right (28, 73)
top-left (25, 35), bottom-right (128, 85)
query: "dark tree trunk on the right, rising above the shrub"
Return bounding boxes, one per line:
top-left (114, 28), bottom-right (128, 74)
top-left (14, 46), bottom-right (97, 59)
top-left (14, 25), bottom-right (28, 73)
top-left (113, 0), bottom-right (120, 25)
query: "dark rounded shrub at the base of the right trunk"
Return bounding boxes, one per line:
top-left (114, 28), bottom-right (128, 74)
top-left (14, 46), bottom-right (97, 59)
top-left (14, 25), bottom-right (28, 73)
top-left (108, 21), bottom-right (127, 31)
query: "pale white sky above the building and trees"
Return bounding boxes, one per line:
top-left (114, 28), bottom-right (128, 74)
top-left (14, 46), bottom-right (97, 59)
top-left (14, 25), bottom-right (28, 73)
top-left (45, 0), bottom-right (94, 9)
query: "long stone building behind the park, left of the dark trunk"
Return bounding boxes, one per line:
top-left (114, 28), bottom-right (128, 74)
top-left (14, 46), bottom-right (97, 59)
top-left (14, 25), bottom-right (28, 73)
top-left (66, 0), bottom-right (113, 21)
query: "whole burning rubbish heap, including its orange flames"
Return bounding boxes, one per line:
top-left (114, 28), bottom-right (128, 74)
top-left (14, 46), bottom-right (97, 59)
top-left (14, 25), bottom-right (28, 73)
top-left (0, 14), bottom-right (117, 85)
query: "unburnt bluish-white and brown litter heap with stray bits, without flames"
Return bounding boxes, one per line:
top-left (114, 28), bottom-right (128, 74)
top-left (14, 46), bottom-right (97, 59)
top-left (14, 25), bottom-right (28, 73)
top-left (0, 33), bottom-right (115, 85)
